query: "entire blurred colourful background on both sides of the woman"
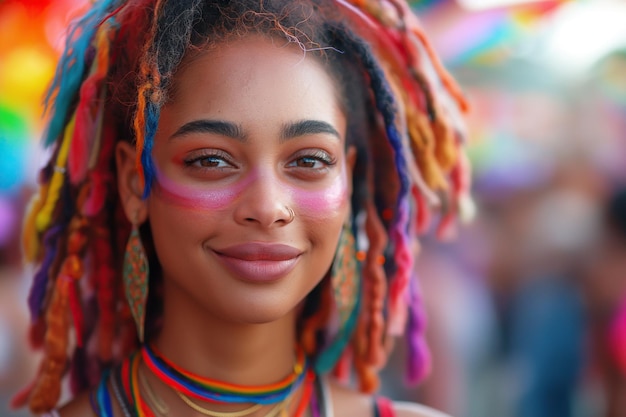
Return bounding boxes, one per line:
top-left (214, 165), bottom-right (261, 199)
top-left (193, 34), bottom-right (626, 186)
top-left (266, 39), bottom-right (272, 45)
top-left (0, 0), bottom-right (626, 417)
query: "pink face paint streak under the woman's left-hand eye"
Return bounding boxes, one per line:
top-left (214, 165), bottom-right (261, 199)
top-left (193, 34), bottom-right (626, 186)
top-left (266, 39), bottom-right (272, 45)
top-left (155, 170), bottom-right (250, 211)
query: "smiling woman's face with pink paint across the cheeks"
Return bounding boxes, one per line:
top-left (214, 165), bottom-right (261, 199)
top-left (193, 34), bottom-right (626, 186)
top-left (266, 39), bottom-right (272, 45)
top-left (147, 36), bottom-right (352, 323)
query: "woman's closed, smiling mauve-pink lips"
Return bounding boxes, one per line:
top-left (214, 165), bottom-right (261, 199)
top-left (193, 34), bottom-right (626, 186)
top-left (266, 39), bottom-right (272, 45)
top-left (213, 243), bottom-right (302, 283)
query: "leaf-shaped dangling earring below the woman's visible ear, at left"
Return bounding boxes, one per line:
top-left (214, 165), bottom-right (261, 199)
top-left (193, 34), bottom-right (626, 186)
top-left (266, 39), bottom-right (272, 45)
top-left (123, 218), bottom-right (150, 343)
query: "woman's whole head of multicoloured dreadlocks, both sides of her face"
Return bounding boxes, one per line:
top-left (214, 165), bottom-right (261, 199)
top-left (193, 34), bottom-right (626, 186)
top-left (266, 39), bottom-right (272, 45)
top-left (14, 0), bottom-right (469, 412)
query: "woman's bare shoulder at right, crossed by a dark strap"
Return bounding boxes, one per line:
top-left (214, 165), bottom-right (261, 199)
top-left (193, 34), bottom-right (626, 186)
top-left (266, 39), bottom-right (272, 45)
top-left (327, 379), bottom-right (450, 417)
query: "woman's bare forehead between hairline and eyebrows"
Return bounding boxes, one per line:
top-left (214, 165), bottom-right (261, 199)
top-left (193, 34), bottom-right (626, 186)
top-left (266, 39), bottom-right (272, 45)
top-left (160, 35), bottom-right (344, 138)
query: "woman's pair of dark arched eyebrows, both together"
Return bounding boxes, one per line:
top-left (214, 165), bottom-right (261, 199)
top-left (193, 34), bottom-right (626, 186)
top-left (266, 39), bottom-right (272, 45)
top-left (170, 119), bottom-right (341, 142)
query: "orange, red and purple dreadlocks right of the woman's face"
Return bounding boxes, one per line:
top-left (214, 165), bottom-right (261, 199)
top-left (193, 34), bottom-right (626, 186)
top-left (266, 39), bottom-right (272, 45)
top-left (310, 0), bottom-right (469, 391)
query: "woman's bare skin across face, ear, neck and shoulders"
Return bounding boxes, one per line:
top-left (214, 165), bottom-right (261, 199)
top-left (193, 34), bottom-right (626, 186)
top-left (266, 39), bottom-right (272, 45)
top-left (61, 36), bottom-right (442, 417)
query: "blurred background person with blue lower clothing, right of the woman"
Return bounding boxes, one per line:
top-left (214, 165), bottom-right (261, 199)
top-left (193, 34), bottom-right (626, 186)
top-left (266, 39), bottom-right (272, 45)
top-left (510, 165), bottom-right (598, 417)
